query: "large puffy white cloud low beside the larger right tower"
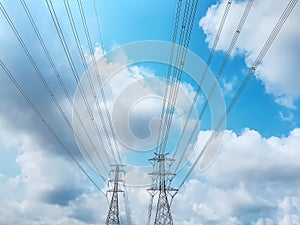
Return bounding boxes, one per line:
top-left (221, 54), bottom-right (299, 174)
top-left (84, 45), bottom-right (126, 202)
top-left (173, 128), bottom-right (300, 225)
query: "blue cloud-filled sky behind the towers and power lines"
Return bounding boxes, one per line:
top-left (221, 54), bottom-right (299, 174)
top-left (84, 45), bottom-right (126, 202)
top-left (0, 0), bottom-right (300, 225)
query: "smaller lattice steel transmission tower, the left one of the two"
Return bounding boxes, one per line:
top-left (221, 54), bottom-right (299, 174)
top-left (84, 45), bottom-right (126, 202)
top-left (105, 164), bottom-right (125, 225)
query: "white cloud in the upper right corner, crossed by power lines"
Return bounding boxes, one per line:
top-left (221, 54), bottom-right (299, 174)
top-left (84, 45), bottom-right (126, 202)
top-left (199, 0), bottom-right (300, 108)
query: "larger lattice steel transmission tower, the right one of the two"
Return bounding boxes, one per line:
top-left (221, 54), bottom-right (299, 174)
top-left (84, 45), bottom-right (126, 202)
top-left (147, 153), bottom-right (177, 225)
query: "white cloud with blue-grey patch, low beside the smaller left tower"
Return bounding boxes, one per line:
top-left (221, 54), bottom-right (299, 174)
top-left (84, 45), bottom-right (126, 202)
top-left (0, 131), bottom-right (106, 225)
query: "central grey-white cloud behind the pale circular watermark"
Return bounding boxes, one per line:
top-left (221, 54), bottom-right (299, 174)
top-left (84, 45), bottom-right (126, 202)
top-left (73, 44), bottom-right (202, 185)
